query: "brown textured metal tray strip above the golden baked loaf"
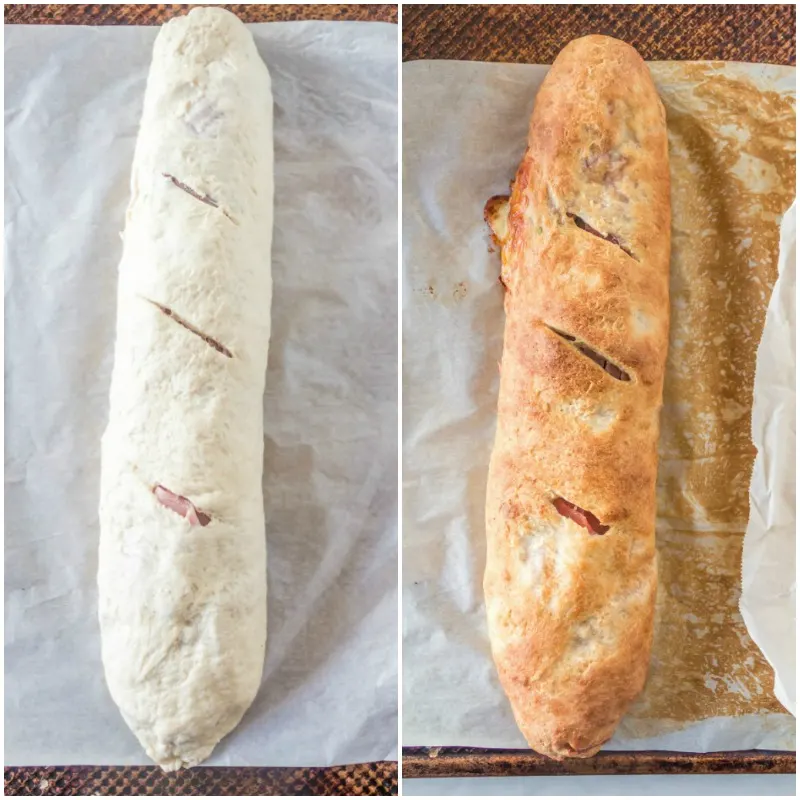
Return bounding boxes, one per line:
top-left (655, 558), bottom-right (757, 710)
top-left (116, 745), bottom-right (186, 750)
top-left (403, 4), bottom-right (796, 65)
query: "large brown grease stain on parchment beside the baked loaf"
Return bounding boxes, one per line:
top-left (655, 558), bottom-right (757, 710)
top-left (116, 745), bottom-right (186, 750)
top-left (625, 64), bottom-right (795, 735)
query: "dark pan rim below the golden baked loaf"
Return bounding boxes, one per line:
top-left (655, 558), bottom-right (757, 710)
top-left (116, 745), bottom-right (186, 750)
top-left (402, 747), bottom-right (797, 778)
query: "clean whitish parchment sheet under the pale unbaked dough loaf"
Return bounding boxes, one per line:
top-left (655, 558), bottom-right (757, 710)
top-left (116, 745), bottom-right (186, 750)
top-left (4, 22), bottom-right (397, 766)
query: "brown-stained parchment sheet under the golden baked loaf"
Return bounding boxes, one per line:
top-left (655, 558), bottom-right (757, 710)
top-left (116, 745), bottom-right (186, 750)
top-left (402, 61), bottom-right (795, 752)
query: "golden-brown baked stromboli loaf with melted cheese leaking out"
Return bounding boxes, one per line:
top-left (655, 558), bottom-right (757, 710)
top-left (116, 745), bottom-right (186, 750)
top-left (484, 36), bottom-right (670, 759)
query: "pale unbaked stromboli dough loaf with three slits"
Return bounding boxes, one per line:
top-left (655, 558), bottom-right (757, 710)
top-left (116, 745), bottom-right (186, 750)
top-left (98, 8), bottom-right (273, 770)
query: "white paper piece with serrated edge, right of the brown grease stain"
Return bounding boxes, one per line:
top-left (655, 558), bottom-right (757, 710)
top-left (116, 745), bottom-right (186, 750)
top-left (739, 204), bottom-right (797, 716)
